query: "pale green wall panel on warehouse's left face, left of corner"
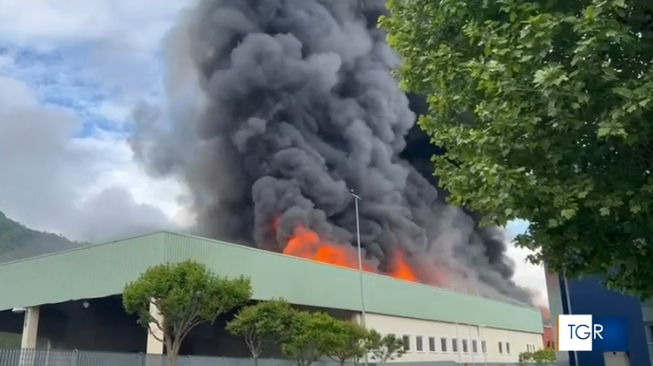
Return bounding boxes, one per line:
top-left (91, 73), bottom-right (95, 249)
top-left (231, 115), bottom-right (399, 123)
top-left (0, 233), bottom-right (166, 310)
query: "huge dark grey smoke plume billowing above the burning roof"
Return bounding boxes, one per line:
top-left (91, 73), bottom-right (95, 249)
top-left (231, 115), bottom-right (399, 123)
top-left (134, 0), bottom-right (530, 301)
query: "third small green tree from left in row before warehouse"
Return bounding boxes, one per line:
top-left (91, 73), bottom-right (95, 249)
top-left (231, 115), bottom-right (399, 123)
top-left (281, 311), bottom-right (345, 366)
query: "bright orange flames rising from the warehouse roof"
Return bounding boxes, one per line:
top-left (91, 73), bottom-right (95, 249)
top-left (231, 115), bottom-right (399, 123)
top-left (274, 219), bottom-right (439, 284)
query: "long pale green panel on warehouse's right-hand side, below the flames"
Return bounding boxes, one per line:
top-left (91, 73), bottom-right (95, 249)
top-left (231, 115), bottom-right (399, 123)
top-left (160, 234), bottom-right (542, 333)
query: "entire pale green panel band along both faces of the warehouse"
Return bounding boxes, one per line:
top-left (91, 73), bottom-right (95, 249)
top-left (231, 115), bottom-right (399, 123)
top-left (0, 232), bottom-right (542, 333)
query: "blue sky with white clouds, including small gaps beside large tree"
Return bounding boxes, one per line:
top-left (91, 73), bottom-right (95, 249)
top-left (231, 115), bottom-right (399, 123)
top-left (0, 0), bottom-right (543, 300)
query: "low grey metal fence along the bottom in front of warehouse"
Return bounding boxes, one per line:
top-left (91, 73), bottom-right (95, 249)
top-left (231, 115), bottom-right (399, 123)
top-left (0, 349), bottom-right (563, 366)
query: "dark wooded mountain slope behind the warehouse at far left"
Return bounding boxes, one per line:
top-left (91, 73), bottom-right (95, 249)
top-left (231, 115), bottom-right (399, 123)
top-left (0, 212), bottom-right (83, 263)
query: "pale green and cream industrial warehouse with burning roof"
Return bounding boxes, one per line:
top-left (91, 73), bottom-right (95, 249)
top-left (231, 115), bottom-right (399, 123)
top-left (0, 232), bottom-right (543, 364)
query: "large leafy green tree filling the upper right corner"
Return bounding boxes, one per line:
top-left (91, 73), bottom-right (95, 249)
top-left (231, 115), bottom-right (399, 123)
top-left (381, 0), bottom-right (653, 297)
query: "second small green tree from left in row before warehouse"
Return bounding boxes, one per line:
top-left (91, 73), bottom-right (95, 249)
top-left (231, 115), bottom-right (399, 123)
top-left (226, 299), bottom-right (296, 365)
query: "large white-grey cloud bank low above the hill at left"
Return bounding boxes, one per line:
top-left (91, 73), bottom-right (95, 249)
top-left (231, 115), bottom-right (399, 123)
top-left (0, 73), bottom-right (186, 241)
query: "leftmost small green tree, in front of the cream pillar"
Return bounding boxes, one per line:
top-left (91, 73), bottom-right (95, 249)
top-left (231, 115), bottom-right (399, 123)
top-left (122, 261), bottom-right (252, 366)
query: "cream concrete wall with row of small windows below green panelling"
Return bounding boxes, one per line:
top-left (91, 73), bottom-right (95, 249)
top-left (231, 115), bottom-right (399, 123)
top-left (356, 313), bottom-right (542, 364)
